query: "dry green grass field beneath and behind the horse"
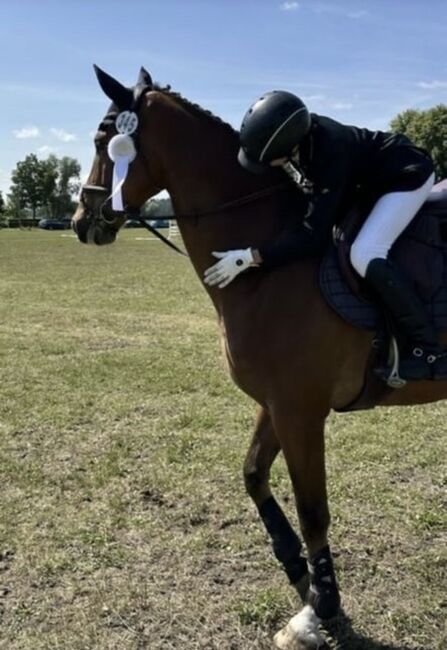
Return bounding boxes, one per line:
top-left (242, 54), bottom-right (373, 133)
top-left (0, 231), bottom-right (447, 650)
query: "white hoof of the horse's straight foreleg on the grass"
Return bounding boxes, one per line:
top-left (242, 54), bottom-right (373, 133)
top-left (273, 605), bottom-right (324, 650)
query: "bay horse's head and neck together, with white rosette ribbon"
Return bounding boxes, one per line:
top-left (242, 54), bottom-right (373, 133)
top-left (72, 66), bottom-right (301, 276)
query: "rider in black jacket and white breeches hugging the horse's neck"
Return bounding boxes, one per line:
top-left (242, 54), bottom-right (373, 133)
top-left (205, 91), bottom-right (447, 380)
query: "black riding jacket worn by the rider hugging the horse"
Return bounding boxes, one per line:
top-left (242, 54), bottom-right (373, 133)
top-left (259, 114), bottom-right (433, 268)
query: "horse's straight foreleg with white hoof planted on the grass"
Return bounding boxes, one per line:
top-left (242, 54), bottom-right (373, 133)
top-left (273, 404), bottom-right (340, 648)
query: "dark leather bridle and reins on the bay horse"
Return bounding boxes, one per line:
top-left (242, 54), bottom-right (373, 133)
top-left (80, 100), bottom-right (290, 255)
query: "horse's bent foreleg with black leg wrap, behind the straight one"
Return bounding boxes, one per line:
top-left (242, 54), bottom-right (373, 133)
top-left (244, 408), bottom-right (309, 600)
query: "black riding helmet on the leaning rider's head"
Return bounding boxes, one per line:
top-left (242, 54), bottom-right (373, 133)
top-left (238, 90), bottom-right (310, 173)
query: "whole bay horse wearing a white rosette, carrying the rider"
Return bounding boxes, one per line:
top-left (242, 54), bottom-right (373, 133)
top-left (73, 67), bottom-right (447, 649)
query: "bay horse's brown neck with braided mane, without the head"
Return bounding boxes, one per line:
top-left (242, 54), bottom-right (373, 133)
top-left (149, 94), bottom-right (286, 277)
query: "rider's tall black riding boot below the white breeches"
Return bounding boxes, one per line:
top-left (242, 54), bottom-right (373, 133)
top-left (365, 258), bottom-right (447, 380)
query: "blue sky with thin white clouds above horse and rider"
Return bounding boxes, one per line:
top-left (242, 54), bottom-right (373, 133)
top-left (0, 0), bottom-right (447, 193)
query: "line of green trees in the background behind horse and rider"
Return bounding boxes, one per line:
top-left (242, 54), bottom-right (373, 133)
top-left (0, 104), bottom-right (447, 223)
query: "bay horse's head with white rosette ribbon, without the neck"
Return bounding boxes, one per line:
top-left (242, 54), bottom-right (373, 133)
top-left (72, 66), bottom-right (164, 245)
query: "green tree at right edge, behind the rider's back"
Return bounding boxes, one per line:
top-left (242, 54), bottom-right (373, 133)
top-left (390, 104), bottom-right (447, 178)
